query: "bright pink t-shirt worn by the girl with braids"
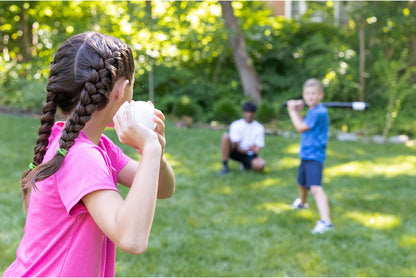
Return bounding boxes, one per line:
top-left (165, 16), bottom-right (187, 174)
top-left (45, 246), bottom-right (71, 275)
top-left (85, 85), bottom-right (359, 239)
top-left (3, 122), bottom-right (129, 277)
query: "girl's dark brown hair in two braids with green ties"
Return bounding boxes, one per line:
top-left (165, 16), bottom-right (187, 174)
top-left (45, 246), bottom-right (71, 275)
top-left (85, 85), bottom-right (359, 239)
top-left (21, 32), bottom-right (134, 207)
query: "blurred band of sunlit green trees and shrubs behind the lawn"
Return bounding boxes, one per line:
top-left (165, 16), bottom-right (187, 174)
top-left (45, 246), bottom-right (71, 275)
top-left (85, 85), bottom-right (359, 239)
top-left (0, 1), bottom-right (416, 136)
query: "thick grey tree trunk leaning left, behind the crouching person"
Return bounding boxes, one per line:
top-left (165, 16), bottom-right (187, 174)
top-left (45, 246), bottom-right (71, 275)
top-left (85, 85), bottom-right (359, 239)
top-left (219, 1), bottom-right (261, 104)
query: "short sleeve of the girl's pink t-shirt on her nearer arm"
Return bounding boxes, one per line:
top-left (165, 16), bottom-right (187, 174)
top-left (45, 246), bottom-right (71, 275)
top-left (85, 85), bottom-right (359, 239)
top-left (56, 144), bottom-right (122, 215)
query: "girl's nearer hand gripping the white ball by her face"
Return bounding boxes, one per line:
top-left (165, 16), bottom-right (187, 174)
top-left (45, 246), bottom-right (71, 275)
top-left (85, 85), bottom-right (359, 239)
top-left (113, 102), bottom-right (159, 153)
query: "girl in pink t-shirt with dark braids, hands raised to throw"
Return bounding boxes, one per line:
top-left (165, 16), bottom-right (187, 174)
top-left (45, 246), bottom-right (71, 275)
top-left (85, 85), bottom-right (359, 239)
top-left (3, 32), bottom-right (175, 277)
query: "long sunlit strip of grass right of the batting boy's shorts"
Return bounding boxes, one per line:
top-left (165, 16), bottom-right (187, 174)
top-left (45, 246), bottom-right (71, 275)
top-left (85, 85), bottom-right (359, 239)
top-left (324, 155), bottom-right (416, 178)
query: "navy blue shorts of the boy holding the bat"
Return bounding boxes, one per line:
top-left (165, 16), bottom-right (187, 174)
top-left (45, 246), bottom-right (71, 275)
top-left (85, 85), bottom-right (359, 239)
top-left (297, 159), bottom-right (324, 189)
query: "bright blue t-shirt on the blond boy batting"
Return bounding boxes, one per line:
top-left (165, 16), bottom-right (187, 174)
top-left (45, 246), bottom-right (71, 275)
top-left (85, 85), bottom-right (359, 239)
top-left (299, 103), bottom-right (329, 163)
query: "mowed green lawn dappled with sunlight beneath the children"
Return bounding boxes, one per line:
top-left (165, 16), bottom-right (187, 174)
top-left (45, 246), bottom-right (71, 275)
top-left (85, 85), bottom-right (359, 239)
top-left (0, 115), bottom-right (416, 276)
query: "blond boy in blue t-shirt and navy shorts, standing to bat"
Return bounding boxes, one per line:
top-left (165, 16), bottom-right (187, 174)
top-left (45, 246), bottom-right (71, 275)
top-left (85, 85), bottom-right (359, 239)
top-left (287, 78), bottom-right (333, 234)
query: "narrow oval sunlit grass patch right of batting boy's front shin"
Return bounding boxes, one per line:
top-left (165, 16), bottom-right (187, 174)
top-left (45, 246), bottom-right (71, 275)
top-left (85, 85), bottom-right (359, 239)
top-left (347, 211), bottom-right (401, 229)
